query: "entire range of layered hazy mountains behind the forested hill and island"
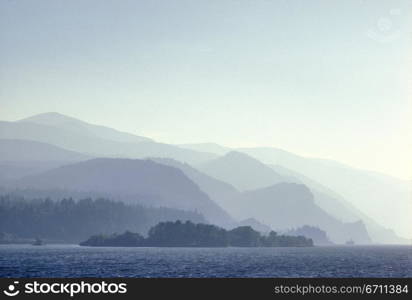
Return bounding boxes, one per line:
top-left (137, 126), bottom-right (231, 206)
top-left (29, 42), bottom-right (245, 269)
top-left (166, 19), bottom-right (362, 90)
top-left (0, 113), bottom-right (412, 243)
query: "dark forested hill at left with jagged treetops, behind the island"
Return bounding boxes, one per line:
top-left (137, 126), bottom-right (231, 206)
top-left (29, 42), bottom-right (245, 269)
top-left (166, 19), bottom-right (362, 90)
top-left (0, 196), bottom-right (206, 243)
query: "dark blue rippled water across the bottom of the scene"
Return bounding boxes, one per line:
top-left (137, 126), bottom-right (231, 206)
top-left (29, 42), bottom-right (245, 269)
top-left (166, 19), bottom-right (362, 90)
top-left (0, 245), bottom-right (412, 277)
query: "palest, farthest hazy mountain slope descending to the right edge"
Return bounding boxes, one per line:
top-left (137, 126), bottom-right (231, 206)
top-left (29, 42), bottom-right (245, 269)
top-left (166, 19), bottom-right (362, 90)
top-left (182, 144), bottom-right (412, 243)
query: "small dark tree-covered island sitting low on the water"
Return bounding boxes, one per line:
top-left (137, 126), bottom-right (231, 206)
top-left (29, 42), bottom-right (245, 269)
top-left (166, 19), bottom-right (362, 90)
top-left (80, 221), bottom-right (313, 247)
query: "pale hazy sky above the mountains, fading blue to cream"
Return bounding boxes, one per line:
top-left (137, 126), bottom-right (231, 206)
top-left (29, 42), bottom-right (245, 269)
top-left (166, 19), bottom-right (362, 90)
top-left (0, 0), bottom-right (412, 178)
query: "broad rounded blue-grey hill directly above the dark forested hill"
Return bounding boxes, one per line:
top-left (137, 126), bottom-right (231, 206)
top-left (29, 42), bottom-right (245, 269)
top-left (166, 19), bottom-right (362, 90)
top-left (15, 158), bottom-right (231, 225)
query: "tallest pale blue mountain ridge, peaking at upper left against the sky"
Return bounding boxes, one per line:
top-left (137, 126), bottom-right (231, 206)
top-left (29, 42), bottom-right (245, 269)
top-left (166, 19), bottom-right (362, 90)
top-left (0, 113), bottom-right (216, 163)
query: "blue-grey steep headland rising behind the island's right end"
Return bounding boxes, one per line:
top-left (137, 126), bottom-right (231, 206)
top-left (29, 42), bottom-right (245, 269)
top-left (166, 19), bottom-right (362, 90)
top-left (230, 183), bottom-right (371, 244)
